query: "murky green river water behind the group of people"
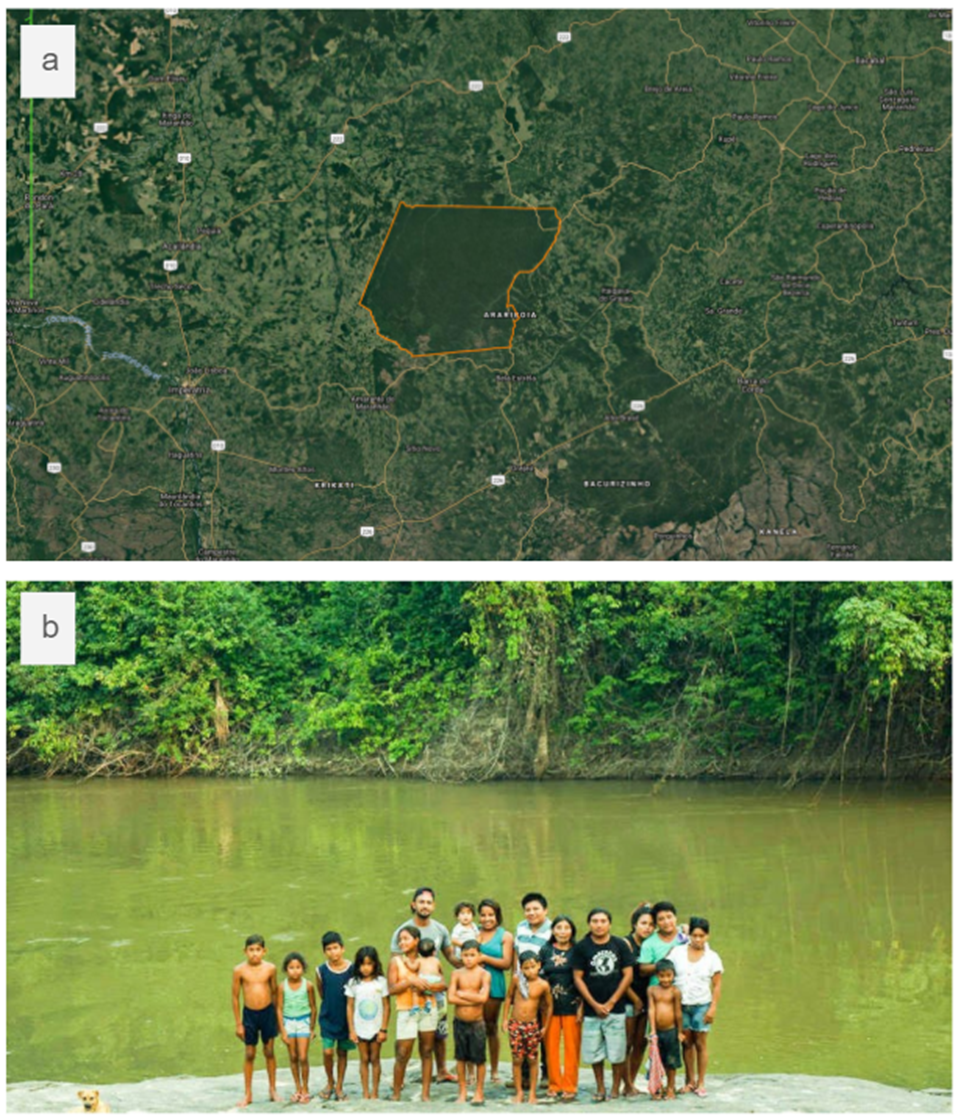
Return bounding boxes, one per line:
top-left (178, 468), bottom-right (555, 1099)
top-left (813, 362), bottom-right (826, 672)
top-left (7, 779), bottom-right (951, 1088)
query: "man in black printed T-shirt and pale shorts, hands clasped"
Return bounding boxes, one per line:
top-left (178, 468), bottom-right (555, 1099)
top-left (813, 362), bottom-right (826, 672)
top-left (571, 909), bottom-right (635, 1103)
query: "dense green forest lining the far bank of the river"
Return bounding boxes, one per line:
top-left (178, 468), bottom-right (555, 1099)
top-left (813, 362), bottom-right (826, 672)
top-left (7, 582), bottom-right (951, 781)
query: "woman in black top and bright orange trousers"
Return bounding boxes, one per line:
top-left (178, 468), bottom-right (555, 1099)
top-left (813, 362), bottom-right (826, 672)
top-left (540, 915), bottom-right (584, 1102)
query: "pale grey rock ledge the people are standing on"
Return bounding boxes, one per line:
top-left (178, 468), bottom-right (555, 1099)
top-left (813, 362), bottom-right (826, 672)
top-left (7, 1060), bottom-right (951, 1115)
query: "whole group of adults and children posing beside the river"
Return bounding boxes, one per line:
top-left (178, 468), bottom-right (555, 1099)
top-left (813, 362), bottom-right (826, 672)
top-left (233, 886), bottom-right (724, 1107)
